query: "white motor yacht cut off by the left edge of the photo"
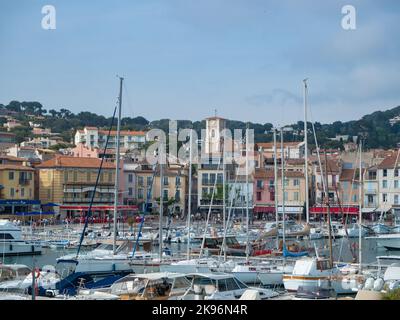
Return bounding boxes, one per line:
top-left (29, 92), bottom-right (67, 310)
top-left (0, 220), bottom-right (42, 256)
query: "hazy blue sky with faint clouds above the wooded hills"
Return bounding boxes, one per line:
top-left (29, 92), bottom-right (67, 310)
top-left (0, 0), bottom-right (400, 124)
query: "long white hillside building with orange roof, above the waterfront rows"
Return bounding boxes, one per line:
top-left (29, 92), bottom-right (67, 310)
top-left (75, 127), bottom-right (146, 150)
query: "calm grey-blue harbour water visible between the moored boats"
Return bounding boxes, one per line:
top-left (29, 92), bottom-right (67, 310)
top-left (1, 238), bottom-right (400, 267)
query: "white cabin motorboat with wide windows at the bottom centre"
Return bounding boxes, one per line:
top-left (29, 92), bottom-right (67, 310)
top-left (176, 272), bottom-right (279, 300)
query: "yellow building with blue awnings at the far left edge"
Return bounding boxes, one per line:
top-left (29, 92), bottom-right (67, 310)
top-left (0, 164), bottom-right (40, 218)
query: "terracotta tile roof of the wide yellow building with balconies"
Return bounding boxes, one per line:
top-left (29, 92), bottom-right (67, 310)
top-left (37, 155), bottom-right (115, 169)
